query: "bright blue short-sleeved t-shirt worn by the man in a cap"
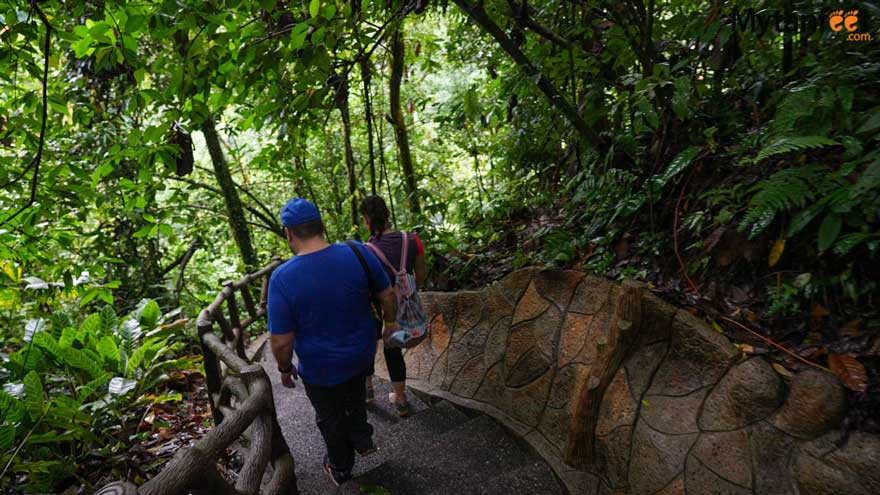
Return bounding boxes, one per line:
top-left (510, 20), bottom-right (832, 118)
top-left (268, 242), bottom-right (391, 387)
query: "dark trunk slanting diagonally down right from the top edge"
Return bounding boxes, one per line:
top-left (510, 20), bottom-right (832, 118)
top-left (450, 0), bottom-right (599, 146)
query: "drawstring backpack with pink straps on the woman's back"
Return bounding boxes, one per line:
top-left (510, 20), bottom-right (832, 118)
top-left (366, 232), bottom-right (428, 349)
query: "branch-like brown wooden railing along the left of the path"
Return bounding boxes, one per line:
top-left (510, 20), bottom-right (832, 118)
top-left (97, 258), bottom-right (298, 495)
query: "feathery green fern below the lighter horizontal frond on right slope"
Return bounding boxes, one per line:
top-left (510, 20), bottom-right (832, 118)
top-left (739, 165), bottom-right (830, 238)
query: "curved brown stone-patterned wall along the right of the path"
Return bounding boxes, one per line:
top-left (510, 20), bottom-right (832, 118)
top-left (377, 269), bottom-right (880, 495)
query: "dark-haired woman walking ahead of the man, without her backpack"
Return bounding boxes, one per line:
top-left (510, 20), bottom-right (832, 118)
top-left (360, 196), bottom-right (425, 417)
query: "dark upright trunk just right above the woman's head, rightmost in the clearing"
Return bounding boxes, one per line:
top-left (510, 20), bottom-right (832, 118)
top-left (389, 24), bottom-right (422, 214)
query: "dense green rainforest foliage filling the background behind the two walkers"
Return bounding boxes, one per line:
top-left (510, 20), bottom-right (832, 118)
top-left (0, 0), bottom-right (880, 492)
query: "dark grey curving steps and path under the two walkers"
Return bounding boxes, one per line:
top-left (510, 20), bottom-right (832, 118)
top-left (263, 356), bottom-right (565, 495)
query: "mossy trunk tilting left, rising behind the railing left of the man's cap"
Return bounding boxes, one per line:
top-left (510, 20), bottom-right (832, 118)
top-left (202, 116), bottom-right (259, 272)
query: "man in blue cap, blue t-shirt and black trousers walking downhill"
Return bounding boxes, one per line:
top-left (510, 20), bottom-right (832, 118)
top-left (268, 198), bottom-right (397, 485)
